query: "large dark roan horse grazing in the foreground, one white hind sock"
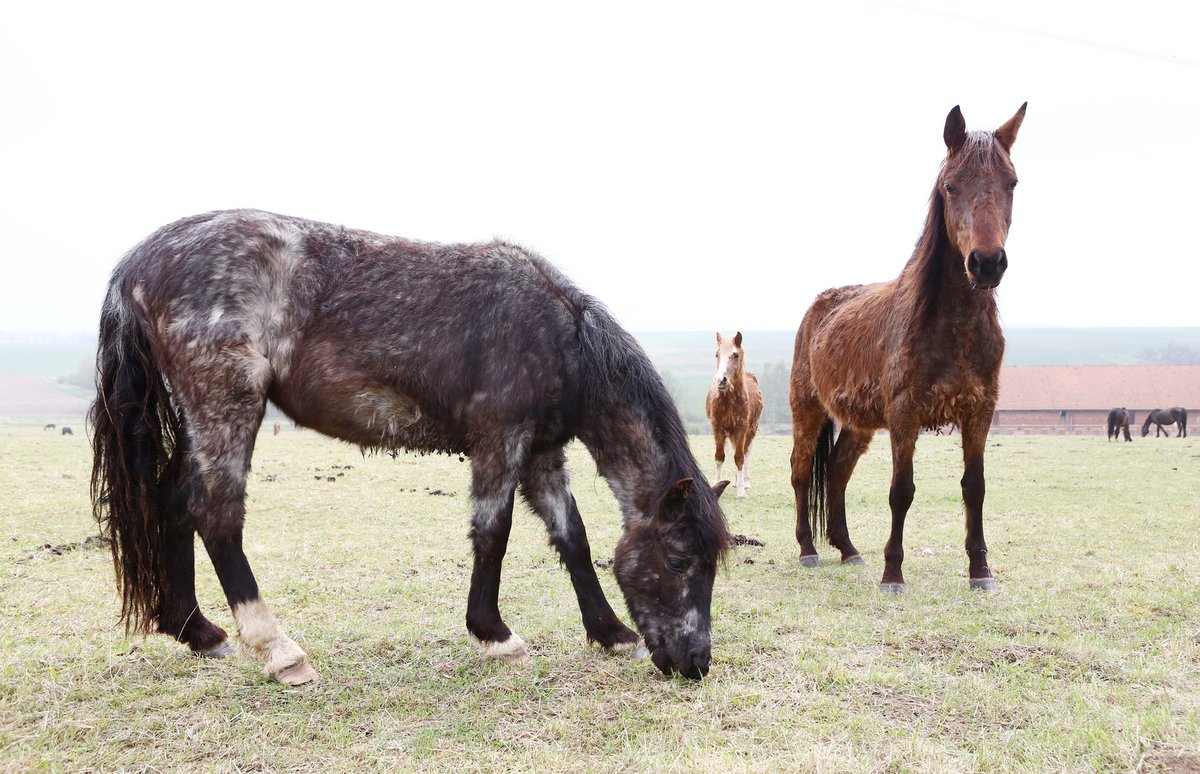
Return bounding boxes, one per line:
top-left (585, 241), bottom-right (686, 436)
top-left (91, 210), bottom-right (730, 684)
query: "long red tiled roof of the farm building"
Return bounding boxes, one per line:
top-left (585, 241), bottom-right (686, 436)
top-left (996, 366), bottom-right (1200, 412)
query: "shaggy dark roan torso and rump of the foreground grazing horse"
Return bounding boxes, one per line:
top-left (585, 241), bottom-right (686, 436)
top-left (114, 210), bottom-right (578, 452)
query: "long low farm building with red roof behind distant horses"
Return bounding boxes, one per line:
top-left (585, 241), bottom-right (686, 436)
top-left (990, 365), bottom-right (1200, 437)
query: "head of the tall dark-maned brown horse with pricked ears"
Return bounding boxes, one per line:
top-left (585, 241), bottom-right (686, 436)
top-left (937, 99), bottom-right (1025, 290)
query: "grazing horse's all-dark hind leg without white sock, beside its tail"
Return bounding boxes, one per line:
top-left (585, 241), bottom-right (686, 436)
top-left (157, 431), bottom-right (233, 659)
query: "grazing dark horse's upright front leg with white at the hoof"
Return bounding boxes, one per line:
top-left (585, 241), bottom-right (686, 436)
top-left (467, 454), bottom-right (529, 662)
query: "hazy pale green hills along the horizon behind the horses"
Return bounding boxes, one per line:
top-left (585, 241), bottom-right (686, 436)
top-left (0, 328), bottom-right (1200, 424)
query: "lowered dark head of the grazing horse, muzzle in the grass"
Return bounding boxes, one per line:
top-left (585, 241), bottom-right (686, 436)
top-left (613, 478), bottom-right (730, 679)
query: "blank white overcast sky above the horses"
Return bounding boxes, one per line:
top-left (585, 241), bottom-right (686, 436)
top-left (0, 0), bottom-right (1200, 331)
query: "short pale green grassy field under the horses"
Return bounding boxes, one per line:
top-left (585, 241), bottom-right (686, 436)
top-left (0, 426), bottom-right (1200, 772)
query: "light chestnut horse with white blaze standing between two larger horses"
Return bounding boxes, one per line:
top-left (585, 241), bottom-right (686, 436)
top-left (704, 331), bottom-right (762, 499)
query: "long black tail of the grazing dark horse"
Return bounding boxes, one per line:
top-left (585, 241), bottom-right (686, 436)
top-left (89, 277), bottom-right (180, 634)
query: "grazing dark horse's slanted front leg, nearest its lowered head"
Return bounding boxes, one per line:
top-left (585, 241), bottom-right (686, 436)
top-left (521, 449), bottom-right (638, 650)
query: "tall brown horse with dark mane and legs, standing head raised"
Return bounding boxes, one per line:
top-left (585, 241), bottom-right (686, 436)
top-left (790, 104), bottom-right (1025, 593)
